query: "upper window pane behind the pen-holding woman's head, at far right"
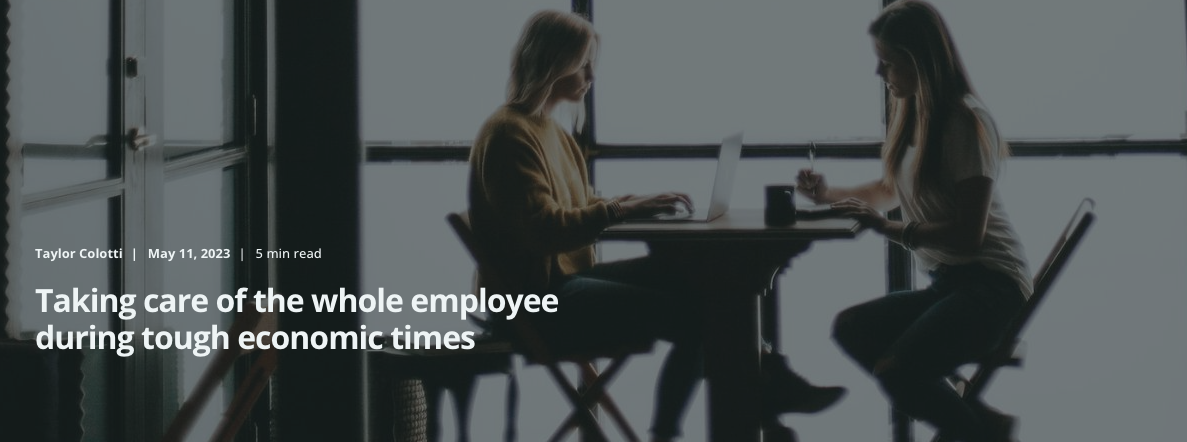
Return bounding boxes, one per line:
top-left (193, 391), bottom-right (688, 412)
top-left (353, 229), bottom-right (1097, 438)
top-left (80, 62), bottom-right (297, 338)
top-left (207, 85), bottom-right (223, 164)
top-left (935, 0), bottom-right (1187, 139)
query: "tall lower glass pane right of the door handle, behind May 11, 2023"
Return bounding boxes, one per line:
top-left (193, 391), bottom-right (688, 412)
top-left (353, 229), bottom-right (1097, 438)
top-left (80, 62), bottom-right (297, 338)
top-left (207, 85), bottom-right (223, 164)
top-left (164, 169), bottom-right (239, 441)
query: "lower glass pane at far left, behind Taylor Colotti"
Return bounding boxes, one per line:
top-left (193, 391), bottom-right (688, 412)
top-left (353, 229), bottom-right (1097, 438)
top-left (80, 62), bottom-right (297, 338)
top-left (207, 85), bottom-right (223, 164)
top-left (16, 200), bottom-right (115, 442)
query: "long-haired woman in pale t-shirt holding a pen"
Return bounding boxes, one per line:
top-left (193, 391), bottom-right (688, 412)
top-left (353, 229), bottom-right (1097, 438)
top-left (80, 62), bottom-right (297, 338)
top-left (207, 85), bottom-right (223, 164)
top-left (796, 0), bottom-right (1032, 442)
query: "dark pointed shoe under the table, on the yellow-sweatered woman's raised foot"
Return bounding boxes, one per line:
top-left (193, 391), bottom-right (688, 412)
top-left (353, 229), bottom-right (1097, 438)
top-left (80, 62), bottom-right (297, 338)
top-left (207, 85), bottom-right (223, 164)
top-left (762, 353), bottom-right (845, 416)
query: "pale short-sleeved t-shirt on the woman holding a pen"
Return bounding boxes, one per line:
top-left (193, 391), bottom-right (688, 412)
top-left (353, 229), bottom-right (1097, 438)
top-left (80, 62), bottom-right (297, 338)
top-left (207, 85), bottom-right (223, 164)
top-left (895, 95), bottom-right (1034, 298)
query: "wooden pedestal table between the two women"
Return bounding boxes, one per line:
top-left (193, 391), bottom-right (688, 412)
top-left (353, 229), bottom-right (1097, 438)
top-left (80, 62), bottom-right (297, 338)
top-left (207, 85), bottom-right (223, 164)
top-left (601, 209), bottom-right (861, 442)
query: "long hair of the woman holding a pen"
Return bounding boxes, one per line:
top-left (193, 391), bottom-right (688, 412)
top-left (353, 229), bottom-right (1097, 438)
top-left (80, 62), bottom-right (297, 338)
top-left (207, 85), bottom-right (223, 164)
top-left (869, 0), bottom-right (1009, 195)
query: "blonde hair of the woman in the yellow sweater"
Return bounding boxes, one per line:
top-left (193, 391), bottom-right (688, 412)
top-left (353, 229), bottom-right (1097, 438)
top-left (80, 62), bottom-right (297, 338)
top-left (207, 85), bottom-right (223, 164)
top-left (507, 10), bottom-right (598, 127)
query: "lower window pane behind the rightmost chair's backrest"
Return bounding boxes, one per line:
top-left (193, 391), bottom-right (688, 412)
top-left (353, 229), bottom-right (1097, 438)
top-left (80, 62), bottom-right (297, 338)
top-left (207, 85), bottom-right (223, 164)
top-left (986, 155), bottom-right (1187, 441)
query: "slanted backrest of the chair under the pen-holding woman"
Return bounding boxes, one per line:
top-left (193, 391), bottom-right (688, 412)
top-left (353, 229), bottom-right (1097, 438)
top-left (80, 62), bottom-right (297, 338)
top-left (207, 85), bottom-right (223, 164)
top-left (1005, 198), bottom-right (1097, 339)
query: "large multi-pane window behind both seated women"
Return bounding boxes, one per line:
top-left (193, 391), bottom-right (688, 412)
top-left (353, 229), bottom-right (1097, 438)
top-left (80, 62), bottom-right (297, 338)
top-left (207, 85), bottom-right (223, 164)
top-left (361, 0), bottom-right (1187, 441)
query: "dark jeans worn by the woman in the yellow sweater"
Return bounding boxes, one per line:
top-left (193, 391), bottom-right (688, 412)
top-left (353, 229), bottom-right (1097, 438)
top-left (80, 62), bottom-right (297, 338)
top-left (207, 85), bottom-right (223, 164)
top-left (533, 257), bottom-right (704, 437)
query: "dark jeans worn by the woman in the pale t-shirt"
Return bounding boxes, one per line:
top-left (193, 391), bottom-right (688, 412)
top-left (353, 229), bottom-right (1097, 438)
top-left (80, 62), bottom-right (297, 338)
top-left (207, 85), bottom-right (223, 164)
top-left (833, 264), bottom-right (1024, 442)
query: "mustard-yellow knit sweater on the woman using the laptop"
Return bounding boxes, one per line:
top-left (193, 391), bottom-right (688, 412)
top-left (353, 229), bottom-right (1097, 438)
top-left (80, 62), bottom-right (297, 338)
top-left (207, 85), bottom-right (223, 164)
top-left (469, 106), bottom-right (610, 293)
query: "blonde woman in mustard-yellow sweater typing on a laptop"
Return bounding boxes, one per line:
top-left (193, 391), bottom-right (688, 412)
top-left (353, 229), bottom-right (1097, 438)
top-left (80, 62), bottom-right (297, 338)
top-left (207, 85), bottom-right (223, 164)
top-left (469, 11), bottom-right (843, 441)
